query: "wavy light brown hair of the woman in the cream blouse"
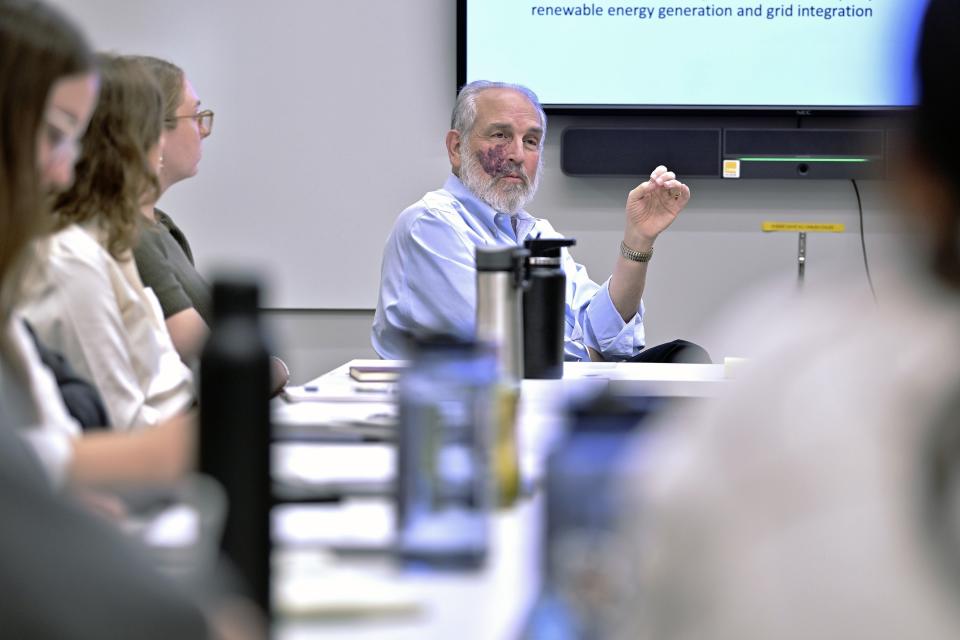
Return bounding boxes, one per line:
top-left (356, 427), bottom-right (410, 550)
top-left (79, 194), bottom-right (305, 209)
top-left (54, 55), bottom-right (163, 260)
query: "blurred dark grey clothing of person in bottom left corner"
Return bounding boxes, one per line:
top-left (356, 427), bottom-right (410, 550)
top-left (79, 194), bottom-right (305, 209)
top-left (0, 410), bottom-right (208, 640)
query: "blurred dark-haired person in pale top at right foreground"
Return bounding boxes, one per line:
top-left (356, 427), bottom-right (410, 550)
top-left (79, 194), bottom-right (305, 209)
top-left (609, 0), bottom-right (960, 640)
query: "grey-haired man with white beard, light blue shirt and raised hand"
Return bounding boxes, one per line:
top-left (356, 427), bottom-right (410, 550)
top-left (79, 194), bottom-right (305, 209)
top-left (371, 81), bottom-right (705, 361)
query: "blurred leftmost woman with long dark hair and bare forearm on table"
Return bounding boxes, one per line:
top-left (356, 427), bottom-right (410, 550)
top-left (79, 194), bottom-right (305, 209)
top-left (0, 26), bottom-right (194, 487)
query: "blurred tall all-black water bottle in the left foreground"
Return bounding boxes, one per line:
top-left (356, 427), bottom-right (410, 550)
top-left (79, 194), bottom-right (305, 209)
top-left (199, 278), bottom-right (271, 612)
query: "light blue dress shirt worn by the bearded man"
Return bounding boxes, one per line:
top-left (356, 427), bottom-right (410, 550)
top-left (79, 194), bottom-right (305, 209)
top-left (371, 175), bottom-right (644, 360)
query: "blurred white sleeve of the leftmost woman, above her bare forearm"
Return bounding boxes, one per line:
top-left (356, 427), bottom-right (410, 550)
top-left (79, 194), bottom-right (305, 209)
top-left (0, 316), bottom-right (80, 486)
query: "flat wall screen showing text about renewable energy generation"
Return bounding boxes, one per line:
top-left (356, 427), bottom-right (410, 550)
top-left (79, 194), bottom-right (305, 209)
top-left (458, 0), bottom-right (928, 111)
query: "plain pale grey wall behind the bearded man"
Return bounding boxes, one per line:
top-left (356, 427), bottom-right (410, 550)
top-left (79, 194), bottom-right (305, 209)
top-left (56, 0), bottom-right (912, 380)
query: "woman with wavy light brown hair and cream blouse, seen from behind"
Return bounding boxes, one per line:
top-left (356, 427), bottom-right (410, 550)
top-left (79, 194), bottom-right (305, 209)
top-left (23, 56), bottom-right (194, 430)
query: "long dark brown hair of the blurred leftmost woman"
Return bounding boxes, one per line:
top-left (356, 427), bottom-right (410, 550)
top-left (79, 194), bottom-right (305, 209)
top-left (0, 0), bottom-right (95, 326)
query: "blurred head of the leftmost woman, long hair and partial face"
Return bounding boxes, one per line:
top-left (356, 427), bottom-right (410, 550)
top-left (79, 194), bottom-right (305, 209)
top-left (0, 0), bottom-right (97, 326)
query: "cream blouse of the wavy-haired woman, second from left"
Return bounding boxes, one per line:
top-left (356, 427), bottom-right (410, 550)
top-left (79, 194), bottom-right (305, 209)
top-left (22, 225), bottom-right (194, 430)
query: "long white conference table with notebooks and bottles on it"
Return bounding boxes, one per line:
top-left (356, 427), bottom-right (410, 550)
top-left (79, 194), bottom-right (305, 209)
top-left (272, 360), bottom-right (729, 640)
